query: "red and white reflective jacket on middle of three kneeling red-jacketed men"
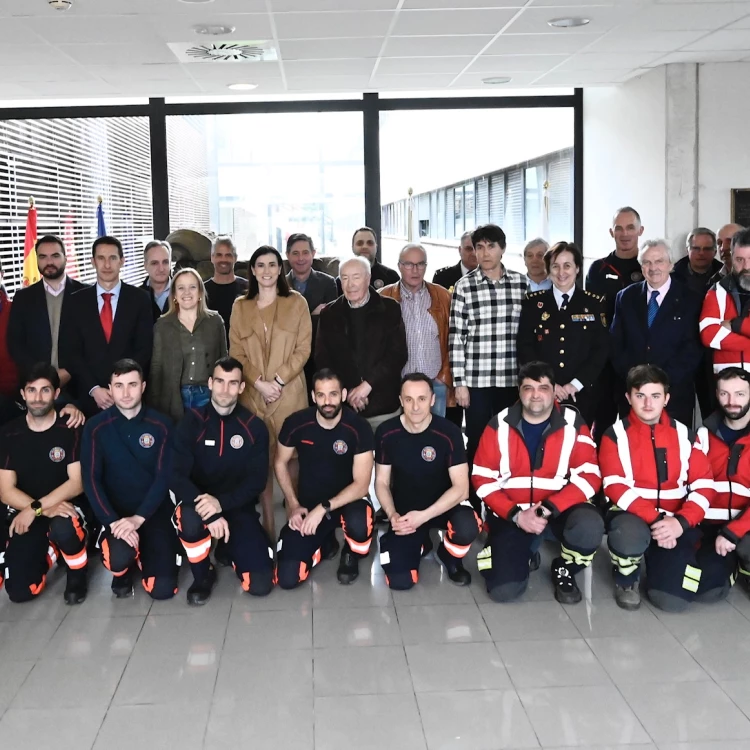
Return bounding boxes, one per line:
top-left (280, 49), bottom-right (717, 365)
top-left (599, 411), bottom-right (716, 528)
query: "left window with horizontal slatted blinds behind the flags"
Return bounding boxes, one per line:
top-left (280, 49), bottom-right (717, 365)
top-left (0, 117), bottom-right (153, 293)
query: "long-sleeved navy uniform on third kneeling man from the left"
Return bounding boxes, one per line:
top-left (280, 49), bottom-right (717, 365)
top-left (171, 401), bottom-right (274, 596)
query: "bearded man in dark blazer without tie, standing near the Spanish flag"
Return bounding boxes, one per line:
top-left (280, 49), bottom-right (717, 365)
top-left (8, 234), bottom-right (85, 400)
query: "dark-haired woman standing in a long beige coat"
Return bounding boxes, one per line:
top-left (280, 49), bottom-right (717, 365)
top-left (229, 245), bottom-right (312, 539)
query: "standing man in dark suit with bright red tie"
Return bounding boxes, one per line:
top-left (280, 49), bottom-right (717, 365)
top-left (60, 236), bottom-right (154, 416)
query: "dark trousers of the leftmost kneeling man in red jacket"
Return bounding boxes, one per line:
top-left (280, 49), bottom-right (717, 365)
top-left (477, 503), bottom-right (604, 602)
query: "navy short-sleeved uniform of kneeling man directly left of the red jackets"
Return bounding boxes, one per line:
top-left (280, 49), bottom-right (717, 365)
top-left (375, 416), bottom-right (481, 589)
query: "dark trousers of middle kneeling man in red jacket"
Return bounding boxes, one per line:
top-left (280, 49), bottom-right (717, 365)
top-left (607, 511), bottom-right (736, 612)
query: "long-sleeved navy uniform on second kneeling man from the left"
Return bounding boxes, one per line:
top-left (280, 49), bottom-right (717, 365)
top-left (81, 406), bottom-right (179, 599)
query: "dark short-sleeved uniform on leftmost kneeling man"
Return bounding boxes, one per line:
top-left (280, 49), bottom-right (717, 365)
top-left (0, 415), bottom-right (87, 602)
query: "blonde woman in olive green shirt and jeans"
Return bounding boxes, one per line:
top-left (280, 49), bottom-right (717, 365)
top-left (148, 268), bottom-right (227, 422)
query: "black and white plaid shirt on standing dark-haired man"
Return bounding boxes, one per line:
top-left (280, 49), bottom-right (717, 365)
top-left (448, 267), bottom-right (528, 388)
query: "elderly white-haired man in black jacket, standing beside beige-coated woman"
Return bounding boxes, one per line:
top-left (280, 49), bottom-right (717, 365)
top-left (315, 256), bottom-right (408, 431)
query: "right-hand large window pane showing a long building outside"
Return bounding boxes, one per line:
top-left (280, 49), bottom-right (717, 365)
top-left (380, 107), bottom-right (574, 277)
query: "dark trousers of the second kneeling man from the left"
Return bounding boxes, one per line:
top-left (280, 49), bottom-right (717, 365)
top-left (99, 503), bottom-right (180, 599)
